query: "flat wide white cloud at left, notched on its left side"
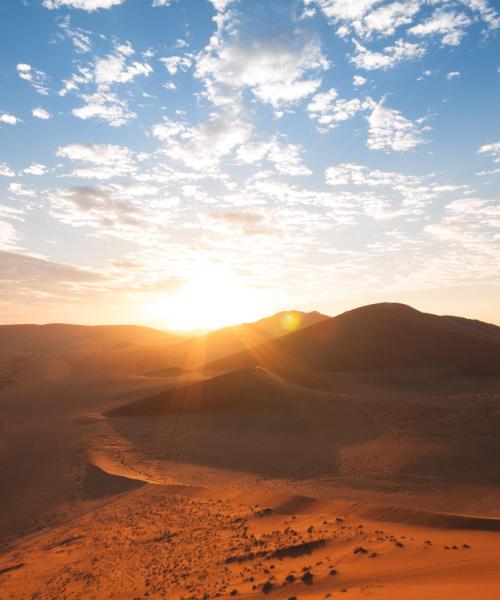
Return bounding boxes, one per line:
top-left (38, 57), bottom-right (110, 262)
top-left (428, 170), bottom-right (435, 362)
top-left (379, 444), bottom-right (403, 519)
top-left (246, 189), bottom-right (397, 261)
top-left (56, 144), bottom-right (136, 179)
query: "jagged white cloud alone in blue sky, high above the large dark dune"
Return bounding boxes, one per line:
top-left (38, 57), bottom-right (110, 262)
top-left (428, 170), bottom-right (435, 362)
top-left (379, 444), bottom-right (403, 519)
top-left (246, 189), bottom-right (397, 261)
top-left (367, 103), bottom-right (424, 152)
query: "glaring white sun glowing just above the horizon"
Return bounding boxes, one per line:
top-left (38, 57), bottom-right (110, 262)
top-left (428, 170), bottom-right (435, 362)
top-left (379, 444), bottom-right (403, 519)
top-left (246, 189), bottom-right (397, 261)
top-left (148, 266), bottom-right (264, 331)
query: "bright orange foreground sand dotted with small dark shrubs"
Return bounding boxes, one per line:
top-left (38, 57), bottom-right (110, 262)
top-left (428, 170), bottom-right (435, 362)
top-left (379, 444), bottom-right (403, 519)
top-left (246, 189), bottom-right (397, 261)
top-left (0, 485), bottom-right (500, 600)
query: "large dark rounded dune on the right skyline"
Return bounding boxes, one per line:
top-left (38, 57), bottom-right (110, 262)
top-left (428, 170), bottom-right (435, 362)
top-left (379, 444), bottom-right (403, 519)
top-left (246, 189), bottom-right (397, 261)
top-left (207, 303), bottom-right (500, 375)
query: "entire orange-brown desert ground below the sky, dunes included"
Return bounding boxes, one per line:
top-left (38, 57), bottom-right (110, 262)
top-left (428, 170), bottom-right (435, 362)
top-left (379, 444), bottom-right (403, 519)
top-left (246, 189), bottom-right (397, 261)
top-left (0, 305), bottom-right (500, 600)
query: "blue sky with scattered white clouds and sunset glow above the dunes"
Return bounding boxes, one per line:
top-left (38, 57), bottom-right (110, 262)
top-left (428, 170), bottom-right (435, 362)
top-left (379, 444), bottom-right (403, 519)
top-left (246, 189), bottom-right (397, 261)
top-left (0, 0), bottom-right (500, 330)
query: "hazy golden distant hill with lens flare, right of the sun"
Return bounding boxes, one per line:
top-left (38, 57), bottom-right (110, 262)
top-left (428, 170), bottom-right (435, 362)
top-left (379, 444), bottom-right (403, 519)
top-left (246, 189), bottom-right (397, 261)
top-left (162, 310), bottom-right (330, 368)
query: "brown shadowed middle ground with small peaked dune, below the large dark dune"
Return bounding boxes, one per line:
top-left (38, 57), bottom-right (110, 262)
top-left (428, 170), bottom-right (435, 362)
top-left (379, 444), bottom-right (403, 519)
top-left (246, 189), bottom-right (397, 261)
top-left (103, 370), bottom-right (500, 491)
